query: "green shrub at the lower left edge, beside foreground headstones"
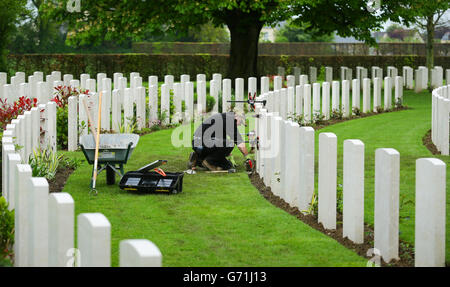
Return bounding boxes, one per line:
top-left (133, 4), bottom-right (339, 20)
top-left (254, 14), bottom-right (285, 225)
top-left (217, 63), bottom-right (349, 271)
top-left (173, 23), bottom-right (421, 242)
top-left (0, 196), bottom-right (14, 266)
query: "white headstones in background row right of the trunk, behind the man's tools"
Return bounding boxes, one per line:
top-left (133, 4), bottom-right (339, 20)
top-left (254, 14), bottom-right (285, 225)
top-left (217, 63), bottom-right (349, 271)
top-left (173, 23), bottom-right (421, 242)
top-left (261, 75), bottom-right (403, 124)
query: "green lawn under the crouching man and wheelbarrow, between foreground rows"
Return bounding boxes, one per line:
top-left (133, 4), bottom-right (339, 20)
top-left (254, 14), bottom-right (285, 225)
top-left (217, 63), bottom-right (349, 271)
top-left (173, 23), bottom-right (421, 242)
top-left (64, 130), bottom-right (366, 266)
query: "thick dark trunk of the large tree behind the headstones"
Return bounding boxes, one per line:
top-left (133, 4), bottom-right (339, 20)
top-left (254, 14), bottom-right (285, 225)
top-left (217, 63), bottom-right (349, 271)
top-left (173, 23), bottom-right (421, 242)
top-left (227, 11), bottom-right (263, 79)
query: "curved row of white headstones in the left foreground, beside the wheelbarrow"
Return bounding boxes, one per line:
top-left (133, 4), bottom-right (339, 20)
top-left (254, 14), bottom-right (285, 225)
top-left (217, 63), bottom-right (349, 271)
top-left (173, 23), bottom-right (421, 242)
top-left (2, 102), bottom-right (162, 267)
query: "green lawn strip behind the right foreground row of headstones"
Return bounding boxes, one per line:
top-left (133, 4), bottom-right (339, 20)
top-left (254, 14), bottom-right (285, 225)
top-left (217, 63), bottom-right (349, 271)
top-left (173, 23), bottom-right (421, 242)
top-left (316, 91), bottom-right (450, 262)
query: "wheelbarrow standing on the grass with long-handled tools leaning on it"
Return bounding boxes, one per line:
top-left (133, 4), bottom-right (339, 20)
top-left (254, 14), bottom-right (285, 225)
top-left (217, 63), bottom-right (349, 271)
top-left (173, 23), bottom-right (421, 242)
top-left (79, 134), bottom-right (139, 185)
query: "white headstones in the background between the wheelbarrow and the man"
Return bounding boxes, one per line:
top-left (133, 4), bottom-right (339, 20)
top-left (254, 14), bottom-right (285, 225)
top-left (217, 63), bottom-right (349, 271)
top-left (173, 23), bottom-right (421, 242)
top-left (68, 73), bottom-right (257, 150)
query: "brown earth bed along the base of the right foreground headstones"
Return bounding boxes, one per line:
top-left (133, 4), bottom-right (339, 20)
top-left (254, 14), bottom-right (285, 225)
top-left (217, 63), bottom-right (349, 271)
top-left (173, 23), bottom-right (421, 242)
top-left (249, 173), bottom-right (414, 267)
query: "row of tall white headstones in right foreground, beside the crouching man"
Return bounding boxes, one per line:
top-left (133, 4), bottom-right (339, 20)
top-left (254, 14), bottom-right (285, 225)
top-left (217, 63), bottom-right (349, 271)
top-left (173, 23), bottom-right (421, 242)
top-left (256, 104), bottom-right (446, 266)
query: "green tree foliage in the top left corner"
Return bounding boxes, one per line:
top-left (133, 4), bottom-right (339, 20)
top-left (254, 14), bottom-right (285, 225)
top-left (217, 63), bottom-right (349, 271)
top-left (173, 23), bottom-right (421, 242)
top-left (0, 0), bottom-right (28, 72)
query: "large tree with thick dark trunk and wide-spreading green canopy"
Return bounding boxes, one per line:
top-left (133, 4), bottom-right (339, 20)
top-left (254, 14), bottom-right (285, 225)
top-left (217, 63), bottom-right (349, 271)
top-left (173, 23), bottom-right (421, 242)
top-left (47, 0), bottom-right (403, 78)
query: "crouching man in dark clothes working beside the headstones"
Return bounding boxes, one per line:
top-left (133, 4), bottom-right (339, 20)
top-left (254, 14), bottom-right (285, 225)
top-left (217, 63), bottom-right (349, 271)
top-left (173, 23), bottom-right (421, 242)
top-left (188, 112), bottom-right (253, 171)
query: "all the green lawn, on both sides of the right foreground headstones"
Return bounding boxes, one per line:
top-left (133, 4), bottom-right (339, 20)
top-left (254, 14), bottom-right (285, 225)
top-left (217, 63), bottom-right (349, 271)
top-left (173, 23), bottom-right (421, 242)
top-left (64, 88), bottom-right (450, 266)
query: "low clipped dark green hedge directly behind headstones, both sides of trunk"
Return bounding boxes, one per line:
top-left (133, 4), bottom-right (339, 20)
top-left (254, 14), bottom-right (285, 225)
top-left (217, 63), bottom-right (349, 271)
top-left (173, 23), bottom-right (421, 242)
top-left (8, 54), bottom-right (450, 79)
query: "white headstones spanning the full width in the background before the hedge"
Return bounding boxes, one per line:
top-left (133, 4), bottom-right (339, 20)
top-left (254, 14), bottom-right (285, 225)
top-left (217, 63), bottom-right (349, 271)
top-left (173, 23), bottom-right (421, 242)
top-left (0, 66), bottom-right (450, 151)
